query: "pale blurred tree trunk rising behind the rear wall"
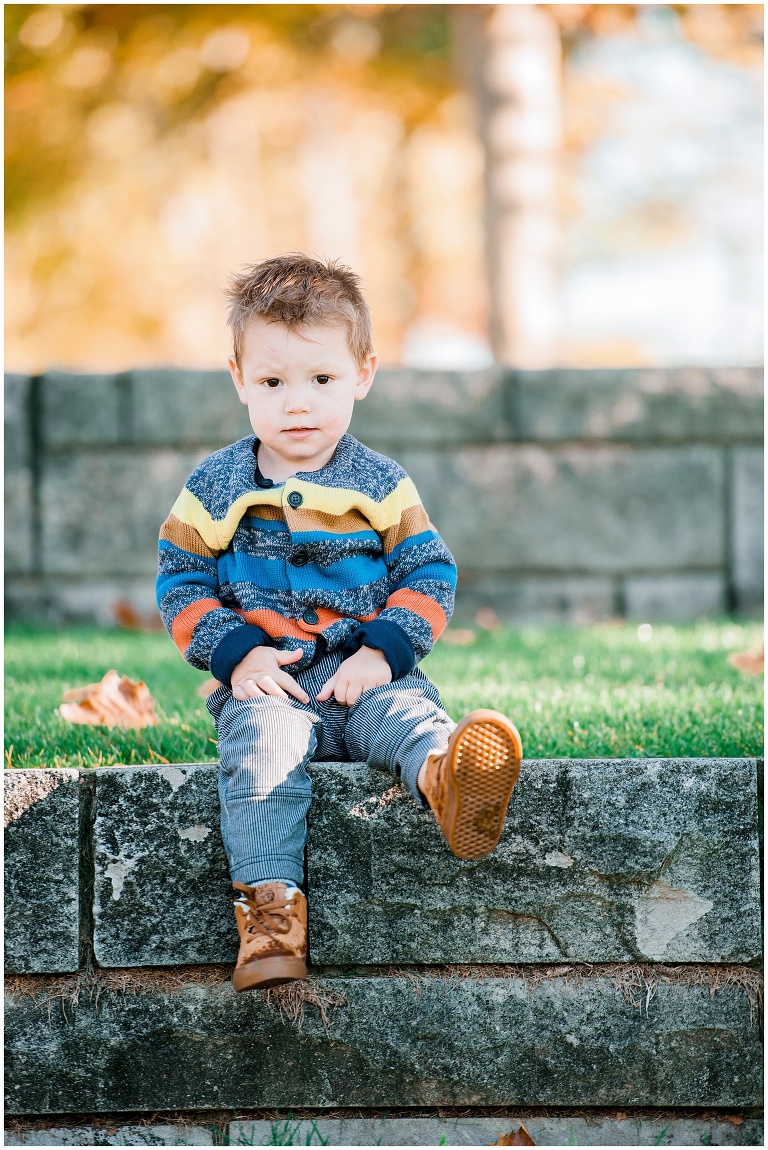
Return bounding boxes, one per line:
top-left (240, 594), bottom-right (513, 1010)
top-left (455, 3), bottom-right (562, 368)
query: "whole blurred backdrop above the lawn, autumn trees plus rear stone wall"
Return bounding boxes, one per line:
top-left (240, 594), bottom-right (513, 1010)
top-left (5, 3), bottom-right (763, 626)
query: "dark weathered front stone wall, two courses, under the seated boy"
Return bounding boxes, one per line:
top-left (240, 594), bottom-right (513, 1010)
top-left (5, 759), bottom-right (762, 1122)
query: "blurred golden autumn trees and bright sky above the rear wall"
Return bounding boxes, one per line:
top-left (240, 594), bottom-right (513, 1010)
top-left (5, 3), bottom-right (762, 373)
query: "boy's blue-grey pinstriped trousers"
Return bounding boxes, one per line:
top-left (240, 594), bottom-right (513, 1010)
top-left (207, 652), bottom-right (455, 886)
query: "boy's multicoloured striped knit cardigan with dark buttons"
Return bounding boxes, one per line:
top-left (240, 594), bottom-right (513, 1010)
top-left (158, 435), bottom-right (456, 683)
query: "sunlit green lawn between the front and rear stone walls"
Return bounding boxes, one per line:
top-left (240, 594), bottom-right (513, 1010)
top-left (6, 621), bottom-right (763, 767)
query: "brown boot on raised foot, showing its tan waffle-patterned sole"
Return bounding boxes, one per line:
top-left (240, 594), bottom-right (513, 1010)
top-left (423, 711), bottom-right (523, 859)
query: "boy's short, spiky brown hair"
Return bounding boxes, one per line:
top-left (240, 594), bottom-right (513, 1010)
top-left (226, 252), bottom-right (374, 367)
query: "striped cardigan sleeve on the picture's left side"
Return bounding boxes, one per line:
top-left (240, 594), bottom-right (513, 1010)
top-left (156, 506), bottom-right (269, 684)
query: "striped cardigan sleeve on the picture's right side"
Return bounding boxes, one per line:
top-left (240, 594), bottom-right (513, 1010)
top-left (344, 477), bottom-right (456, 679)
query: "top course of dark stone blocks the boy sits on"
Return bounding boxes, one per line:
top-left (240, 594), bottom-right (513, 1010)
top-left (6, 759), bottom-right (761, 973)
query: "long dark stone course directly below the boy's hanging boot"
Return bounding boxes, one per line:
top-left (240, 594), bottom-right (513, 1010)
top-left (6, 968), bottom-right (762, 1114)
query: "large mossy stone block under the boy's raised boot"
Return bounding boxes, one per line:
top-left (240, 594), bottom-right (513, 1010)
top-left (307, 759), bottom-right (761, 964)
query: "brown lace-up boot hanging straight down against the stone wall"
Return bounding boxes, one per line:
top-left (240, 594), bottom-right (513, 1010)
top-left (232, 882), bottom-right (307, 990)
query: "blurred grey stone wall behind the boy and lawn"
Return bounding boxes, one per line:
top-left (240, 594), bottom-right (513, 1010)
top-left (6, 368), bottom-right (762, 623)
